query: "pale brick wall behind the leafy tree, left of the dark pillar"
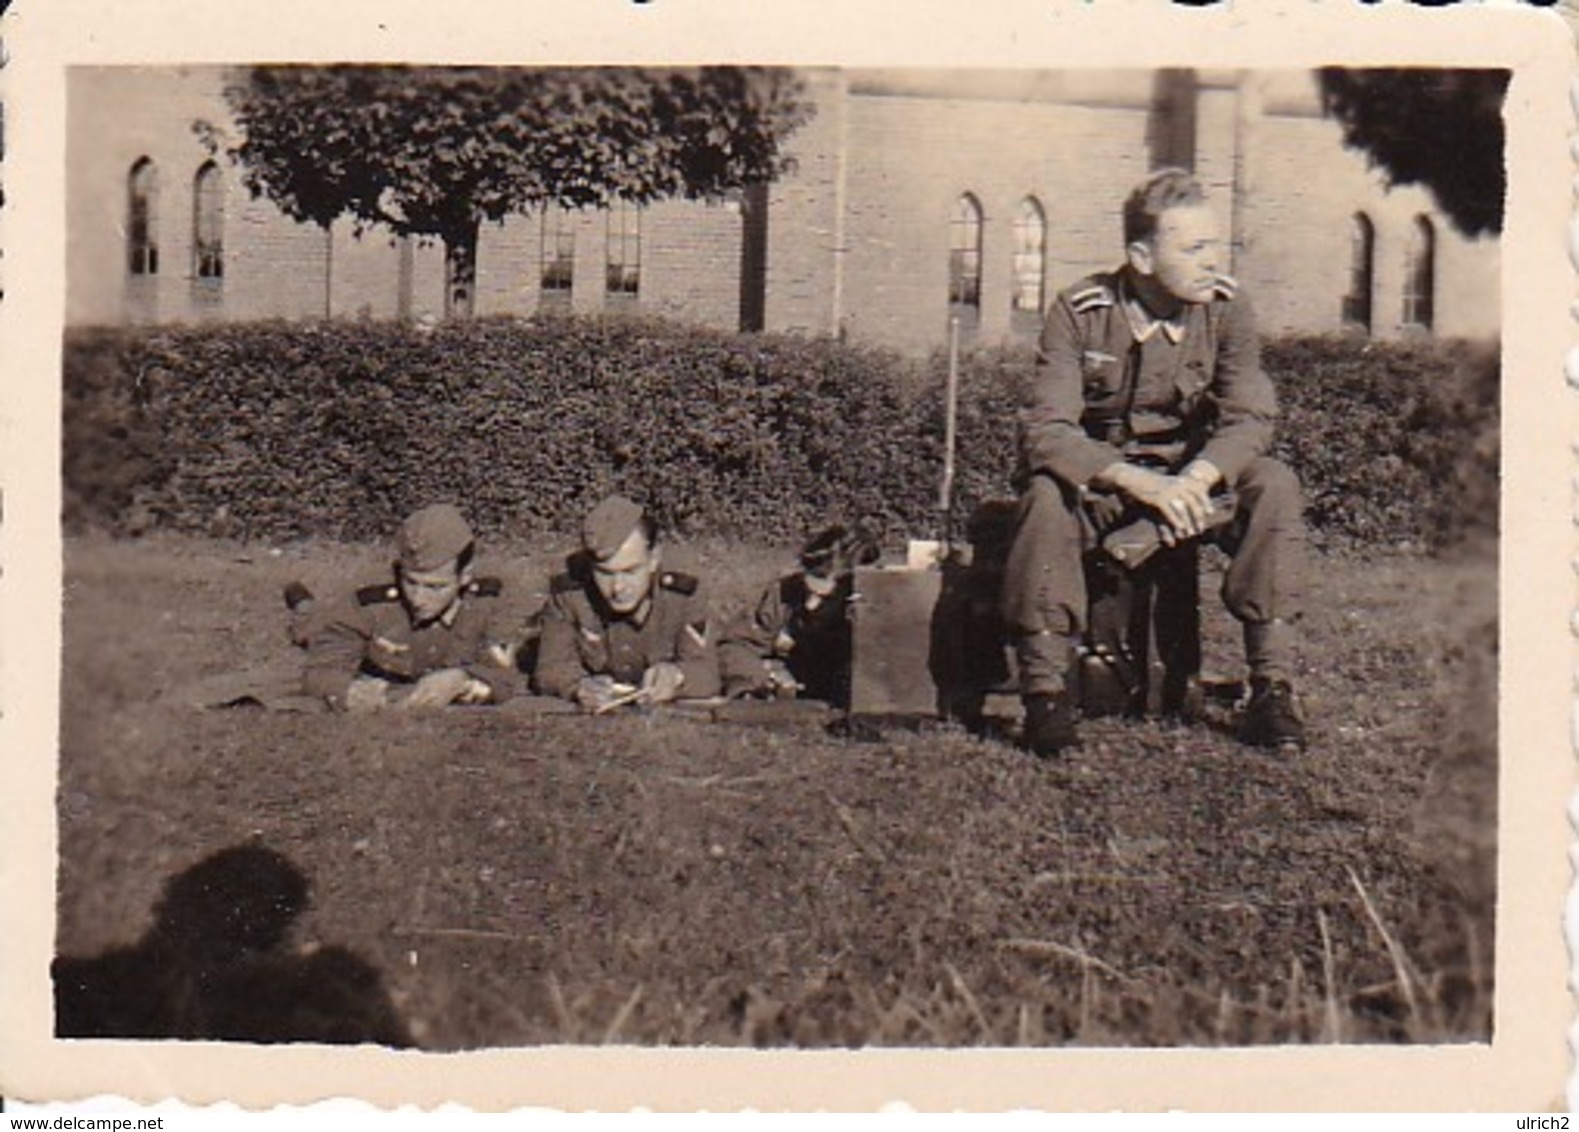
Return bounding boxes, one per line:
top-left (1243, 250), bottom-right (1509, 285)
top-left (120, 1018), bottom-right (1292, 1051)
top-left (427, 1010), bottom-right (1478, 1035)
top-left (66, 68), bottom-right (741, 328)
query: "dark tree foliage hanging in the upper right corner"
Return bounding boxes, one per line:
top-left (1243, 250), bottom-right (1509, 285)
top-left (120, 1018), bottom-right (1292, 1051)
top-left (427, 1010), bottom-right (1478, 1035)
top-left (1320, 66), bottom-right (1508, 237)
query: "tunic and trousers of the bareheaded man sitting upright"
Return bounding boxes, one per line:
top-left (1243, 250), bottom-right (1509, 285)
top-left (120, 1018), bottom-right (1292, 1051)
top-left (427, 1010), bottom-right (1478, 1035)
top-left (1003, 268), bottom-right (1304, 693)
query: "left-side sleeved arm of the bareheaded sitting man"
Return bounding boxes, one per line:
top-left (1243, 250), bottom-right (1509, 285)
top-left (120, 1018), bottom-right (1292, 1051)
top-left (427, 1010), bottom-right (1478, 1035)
top-left (1020, 295), bottom-right (1124, 486)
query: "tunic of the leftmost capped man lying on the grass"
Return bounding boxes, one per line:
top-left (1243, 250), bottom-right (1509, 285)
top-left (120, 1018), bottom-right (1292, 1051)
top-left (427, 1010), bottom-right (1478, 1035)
top-left (302, 578), bottom-right (521, 707)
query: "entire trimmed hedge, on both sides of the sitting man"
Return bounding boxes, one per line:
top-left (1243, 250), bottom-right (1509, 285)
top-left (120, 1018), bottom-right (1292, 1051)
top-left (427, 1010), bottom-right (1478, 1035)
top-left (65, 319), bottom-right (1497, 545)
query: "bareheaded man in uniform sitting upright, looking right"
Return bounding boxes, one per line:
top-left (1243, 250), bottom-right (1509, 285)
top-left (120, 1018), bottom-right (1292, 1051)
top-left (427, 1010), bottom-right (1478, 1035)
top-left (1004, 169), bottom-right (1304, 755)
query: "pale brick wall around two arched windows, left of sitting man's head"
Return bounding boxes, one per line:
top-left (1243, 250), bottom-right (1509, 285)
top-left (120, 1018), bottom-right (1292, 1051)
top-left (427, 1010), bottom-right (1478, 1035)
top-left (842, 88), bottom-right (1146, 352)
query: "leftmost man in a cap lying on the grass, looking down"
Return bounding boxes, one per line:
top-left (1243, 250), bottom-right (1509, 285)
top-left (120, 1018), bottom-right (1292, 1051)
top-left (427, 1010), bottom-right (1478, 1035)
top-left (302, 504), bottom-right (521, 712)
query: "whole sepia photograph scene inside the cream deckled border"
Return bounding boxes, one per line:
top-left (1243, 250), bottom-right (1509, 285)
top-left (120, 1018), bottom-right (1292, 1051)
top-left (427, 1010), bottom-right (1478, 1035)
top-left (6, 0), bottom-right (1565, 1111)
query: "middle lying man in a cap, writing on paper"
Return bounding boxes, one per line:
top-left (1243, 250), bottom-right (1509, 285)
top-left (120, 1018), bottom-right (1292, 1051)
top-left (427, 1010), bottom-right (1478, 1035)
top-left (534, 496), bottom-right (720, 712)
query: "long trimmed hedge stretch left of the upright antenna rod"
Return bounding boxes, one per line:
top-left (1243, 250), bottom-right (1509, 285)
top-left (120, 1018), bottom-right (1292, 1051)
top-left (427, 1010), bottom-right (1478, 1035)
top-left (65, 319), bottom-right (960, 538)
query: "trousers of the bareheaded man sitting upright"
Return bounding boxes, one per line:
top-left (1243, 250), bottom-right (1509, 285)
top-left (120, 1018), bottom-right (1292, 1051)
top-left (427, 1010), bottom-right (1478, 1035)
top-left (1003, 456), bottom-right (1306, 695)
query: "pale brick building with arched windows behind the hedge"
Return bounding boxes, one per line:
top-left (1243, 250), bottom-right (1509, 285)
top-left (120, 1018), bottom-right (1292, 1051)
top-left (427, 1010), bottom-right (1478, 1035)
top-left (66, 66), bottom-right (1500, 350)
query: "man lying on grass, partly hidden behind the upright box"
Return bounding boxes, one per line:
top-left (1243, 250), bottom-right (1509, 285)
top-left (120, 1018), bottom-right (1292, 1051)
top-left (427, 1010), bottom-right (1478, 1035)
top-left (718, 524), bottom-right (878, 707)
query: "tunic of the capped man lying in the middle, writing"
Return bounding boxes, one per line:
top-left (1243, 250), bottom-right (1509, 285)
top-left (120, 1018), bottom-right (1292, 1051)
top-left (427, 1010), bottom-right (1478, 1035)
top-left (535, 572), bottom-right (720, 699)
